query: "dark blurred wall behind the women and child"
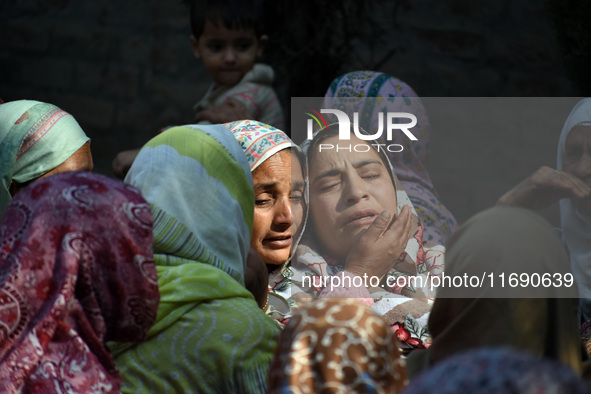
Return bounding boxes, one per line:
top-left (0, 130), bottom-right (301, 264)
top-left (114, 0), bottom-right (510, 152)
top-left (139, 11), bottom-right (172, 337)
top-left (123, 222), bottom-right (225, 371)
top-left (0, 0), bottom-right (591, 226)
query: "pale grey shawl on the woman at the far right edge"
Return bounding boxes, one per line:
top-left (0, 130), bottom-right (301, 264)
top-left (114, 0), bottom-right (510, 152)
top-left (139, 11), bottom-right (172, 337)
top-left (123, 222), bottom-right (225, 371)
top-left (557, 98), bottom-right (591, 298)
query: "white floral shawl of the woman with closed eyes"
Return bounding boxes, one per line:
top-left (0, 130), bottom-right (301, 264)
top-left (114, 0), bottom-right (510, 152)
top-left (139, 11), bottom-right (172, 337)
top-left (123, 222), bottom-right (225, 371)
top-left (291, 125), bottom-right (445, 348)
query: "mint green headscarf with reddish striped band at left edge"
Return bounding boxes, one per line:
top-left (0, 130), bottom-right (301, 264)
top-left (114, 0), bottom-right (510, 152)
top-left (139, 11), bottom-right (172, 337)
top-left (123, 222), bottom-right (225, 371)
top-left (0, 100), bottom-right (89, 219)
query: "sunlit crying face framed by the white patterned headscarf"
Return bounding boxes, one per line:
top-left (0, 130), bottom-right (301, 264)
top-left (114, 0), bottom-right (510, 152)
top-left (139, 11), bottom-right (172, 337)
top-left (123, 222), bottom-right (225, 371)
top-left (250, 149), bottom-right (292, 265)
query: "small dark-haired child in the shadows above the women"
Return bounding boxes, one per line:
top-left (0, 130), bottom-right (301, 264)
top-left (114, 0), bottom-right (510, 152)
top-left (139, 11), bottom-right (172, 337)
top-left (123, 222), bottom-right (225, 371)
top-left (112, 0), bottom-right (284, 178)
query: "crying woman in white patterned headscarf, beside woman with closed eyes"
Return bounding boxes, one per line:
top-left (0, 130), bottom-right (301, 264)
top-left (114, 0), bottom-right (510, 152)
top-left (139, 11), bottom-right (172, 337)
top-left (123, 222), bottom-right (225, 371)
top-left (226, 120), bottom-right (307, 314)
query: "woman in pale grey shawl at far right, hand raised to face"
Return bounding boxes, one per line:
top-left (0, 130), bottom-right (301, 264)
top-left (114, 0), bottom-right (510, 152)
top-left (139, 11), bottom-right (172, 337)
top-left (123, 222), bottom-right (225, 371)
top-left (497, 98), bottom-right (591, 332)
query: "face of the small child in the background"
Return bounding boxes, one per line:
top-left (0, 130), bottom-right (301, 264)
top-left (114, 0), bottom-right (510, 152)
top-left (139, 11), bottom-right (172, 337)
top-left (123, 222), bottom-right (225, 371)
top-left (191, 21), bottom-right (267, 87)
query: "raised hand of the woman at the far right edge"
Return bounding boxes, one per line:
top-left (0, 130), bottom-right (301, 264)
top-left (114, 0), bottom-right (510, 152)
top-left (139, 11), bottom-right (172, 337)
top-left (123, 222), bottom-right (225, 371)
top-left (497, 166), bottom-right (591, 209)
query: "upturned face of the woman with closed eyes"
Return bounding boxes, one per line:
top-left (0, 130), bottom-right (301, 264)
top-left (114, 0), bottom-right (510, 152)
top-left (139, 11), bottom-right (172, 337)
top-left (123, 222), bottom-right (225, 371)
top-left (309, 136), bottom-right (397, 261)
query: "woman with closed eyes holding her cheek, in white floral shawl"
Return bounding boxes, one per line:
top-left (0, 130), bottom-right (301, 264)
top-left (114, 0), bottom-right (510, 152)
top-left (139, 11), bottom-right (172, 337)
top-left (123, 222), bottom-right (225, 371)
top-left (292, 124), bottom-right (444, 348)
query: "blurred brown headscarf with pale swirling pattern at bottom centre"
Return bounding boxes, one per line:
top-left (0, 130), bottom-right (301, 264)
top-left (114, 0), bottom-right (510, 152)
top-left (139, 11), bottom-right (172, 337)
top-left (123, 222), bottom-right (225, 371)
top-left (269, 298), bottom-right (407, 393)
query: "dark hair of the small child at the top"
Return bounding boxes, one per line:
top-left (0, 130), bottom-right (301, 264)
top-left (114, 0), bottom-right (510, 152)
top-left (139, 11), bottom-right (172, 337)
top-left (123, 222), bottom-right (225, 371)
top-left (190, 0), bottom-right (265, 38)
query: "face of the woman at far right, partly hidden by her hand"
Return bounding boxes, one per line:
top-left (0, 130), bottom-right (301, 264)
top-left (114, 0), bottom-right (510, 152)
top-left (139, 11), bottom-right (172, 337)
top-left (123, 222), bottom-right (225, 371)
top-left (562, 126), bottom-right (591, 215)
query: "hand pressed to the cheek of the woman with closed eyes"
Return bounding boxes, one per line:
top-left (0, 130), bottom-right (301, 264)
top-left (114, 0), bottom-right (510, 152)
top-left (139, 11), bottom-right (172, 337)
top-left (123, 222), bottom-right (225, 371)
top-left (345, 206), bottom-right (412, 280)
